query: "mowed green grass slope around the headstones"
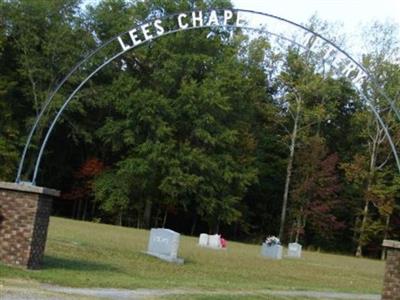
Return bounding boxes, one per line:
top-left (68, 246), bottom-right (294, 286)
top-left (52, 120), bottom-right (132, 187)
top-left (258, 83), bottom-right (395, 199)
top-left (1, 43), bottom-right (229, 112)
top-left (0, 217), bottom-right (384, 294)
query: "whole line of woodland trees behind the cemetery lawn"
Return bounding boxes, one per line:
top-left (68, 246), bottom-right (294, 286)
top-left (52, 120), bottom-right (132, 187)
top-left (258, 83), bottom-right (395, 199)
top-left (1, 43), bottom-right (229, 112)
top-left (0, 0), bottom-right (400, 256)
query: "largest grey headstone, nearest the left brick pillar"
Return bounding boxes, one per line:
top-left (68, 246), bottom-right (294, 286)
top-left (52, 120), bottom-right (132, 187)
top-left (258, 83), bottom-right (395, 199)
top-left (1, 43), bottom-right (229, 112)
top-left (147, 228), bottom-right (183, 264)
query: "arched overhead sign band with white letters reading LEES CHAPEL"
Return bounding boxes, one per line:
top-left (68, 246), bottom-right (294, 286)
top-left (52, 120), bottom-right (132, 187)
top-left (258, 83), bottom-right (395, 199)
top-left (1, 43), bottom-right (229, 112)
top-left (16, 9), bottom-right (400, 185)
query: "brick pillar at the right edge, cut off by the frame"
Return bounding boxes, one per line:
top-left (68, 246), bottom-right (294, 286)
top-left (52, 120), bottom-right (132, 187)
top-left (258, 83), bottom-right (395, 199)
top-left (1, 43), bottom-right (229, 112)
top-left (382, 240), bottom-right (400, 300)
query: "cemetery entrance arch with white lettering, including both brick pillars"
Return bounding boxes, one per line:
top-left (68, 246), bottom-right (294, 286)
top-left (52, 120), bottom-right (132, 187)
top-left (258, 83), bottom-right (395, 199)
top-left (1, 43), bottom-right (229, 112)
top-left (0, 9), bottom-right (400, 299)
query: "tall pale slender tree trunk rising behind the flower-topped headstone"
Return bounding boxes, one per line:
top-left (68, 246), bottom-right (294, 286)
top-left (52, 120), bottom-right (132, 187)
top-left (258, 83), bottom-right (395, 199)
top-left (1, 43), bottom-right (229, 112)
top-left (279, 98), bottom-right (301, 241)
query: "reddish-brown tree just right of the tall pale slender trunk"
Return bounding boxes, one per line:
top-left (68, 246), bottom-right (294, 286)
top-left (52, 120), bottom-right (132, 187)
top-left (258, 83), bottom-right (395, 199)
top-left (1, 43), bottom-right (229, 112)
top-left (290, 136), bottom-right (344, 244)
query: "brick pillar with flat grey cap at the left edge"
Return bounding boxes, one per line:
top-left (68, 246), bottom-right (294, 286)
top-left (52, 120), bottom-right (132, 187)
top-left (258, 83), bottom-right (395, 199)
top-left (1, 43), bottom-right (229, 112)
top-left (0, 182), bottom-right (60, 269)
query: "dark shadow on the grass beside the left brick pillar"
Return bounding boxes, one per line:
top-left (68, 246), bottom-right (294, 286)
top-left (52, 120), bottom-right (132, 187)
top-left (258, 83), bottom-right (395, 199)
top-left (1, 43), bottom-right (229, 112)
top-left (41, 255), bottom-right (119, 272)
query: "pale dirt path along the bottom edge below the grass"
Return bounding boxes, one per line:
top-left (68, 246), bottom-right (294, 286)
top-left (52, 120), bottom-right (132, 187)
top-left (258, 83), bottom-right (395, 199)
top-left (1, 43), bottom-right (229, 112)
top-left (0, 281), bottom-right (380, 300)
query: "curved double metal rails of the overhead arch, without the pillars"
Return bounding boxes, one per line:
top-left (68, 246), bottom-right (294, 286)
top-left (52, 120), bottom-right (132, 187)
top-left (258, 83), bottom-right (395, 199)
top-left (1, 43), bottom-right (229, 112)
top-left (15, 9), bottom-right (400, 185)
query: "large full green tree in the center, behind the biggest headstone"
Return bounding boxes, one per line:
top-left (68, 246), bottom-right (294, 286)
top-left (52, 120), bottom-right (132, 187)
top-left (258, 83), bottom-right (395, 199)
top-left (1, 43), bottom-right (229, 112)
top-left (89, 2), bottom-right (256, 230)
